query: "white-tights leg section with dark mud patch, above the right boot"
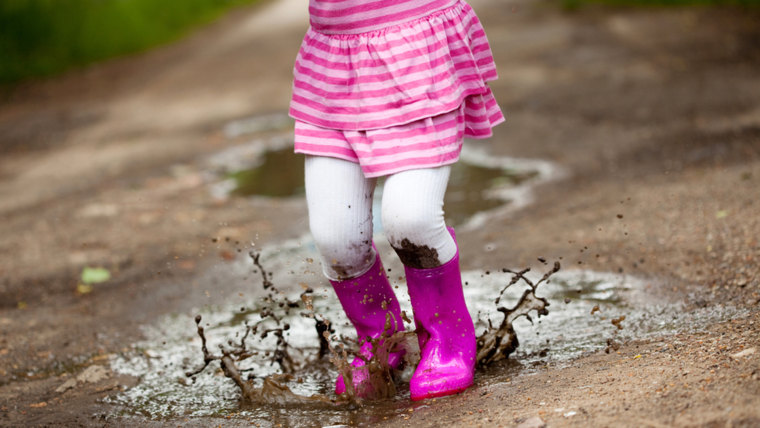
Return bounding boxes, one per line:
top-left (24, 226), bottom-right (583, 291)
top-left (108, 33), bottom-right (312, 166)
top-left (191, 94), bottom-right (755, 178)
top-left (382, 166), bottom-right (457, 269)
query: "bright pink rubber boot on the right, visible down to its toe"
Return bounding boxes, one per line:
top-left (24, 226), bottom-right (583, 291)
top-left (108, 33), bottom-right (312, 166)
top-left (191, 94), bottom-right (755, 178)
top-left (404, 228), bottom-right (476, 401)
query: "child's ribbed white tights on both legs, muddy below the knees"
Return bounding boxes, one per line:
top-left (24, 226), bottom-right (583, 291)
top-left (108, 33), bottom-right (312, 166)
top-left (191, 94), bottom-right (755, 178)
top-left (305, 156), bottom-right (457, 280)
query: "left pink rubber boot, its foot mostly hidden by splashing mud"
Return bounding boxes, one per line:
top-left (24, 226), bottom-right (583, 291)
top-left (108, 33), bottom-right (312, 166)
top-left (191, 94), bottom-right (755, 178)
top-left (330, 245), bottom-right (404, 396)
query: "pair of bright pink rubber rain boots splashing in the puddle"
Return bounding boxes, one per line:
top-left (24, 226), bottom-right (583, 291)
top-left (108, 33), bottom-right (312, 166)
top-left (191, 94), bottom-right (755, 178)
top-left (330, 228), bottom-right (476, 400)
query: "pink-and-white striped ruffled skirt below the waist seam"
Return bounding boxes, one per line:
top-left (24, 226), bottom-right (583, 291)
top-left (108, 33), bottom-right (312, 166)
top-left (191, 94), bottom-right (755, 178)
top-left (289, 1), bottom-right (504, 177)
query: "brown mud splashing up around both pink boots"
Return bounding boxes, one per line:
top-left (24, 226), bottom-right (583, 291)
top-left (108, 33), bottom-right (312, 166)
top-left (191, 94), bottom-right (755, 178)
top-left (186, 252), bottom-right (560, 404)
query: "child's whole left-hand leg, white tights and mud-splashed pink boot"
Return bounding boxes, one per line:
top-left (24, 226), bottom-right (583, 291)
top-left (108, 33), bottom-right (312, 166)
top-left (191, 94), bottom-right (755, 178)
top-left (305, 156), bottom-right (404, 396)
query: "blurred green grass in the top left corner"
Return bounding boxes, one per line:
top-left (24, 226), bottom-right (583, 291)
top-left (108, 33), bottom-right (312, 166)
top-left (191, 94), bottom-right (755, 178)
top-left (0, 0), bottom-right (254, 84)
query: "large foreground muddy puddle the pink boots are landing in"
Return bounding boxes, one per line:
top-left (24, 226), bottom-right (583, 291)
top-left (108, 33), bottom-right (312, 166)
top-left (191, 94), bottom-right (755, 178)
top-left (108, 251), bottom-right (742, 426)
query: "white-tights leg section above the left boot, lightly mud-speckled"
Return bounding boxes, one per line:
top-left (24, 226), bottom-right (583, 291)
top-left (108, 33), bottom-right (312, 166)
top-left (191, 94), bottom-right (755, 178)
top-left (305, 156), bottom-right (376, 280)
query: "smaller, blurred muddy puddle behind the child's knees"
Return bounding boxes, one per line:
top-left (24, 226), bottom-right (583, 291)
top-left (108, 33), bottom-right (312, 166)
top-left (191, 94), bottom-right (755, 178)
top-left (209, 115), bottom-right (562, 229)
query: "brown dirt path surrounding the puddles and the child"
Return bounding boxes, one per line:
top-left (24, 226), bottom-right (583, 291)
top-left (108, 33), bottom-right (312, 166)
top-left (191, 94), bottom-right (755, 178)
top-left (0, 0), bottom-right (760, 426)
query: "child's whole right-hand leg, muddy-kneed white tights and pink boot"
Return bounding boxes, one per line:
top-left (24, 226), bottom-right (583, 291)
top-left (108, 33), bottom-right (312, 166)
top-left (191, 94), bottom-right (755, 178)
top-left (383, 167), bottom-right (476, 400)
